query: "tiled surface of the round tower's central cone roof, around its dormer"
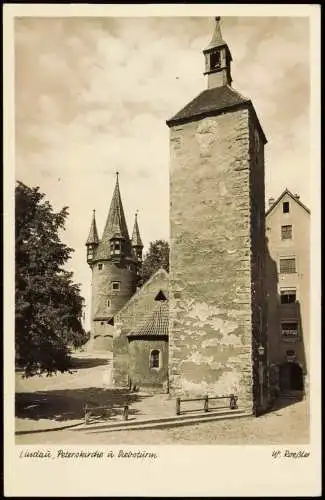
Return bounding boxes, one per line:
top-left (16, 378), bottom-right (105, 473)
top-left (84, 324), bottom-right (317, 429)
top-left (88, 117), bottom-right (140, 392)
top-left (96, 172), bottom-right (132, 259)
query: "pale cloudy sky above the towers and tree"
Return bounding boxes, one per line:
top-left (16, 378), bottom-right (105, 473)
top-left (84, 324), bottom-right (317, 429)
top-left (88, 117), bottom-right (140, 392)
top-left (15, 17), bottom-right (310, 328)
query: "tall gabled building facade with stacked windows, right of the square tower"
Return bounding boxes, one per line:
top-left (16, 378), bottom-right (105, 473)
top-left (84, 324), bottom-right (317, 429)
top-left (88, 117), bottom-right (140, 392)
top-left (266, 189), bottom-right (310, 393)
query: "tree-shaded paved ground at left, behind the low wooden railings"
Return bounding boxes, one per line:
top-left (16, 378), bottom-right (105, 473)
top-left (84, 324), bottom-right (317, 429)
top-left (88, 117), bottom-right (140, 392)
top-left (15, 353), bottom-right (244, 435)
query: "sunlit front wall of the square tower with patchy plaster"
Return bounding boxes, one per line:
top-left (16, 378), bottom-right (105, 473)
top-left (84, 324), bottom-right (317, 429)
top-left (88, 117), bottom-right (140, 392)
top-left (169, 109), bottom-right (264, 410)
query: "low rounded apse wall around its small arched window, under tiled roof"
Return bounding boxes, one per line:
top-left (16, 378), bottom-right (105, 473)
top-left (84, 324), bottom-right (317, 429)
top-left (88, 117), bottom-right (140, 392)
top-left (128, 338), bottom-right (168, 392)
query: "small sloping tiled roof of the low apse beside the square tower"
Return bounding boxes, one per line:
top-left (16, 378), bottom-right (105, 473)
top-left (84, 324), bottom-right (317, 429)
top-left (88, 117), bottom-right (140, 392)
top-left (127, 300), bottom-right (169, 337)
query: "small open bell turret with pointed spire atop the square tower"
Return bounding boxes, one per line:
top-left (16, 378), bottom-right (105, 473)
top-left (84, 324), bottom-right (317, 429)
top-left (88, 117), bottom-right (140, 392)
top-left (203, 17), bottom-right (232, 89)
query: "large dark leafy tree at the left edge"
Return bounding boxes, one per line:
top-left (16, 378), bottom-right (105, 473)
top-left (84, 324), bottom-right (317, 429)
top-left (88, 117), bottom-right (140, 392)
top-left (15, 182), bottom-right (87, 376)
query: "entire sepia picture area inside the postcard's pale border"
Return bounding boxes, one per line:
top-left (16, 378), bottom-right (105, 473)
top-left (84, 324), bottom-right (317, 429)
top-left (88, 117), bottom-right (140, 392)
top-left (3, 5), bottom-right (320, 496)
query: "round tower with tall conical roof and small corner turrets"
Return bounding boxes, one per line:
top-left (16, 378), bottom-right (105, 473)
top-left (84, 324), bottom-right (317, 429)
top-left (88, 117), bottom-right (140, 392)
top-left (86, 174), bottom-right (143, 350)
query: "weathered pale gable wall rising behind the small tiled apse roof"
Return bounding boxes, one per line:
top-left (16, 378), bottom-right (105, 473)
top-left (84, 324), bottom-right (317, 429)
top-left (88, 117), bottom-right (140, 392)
top-left (113, 270), bottom-right (169, 387)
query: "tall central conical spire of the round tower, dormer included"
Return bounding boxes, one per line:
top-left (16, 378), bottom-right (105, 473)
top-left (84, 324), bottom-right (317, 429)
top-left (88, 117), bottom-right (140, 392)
top-left (96, 172), bottom-right (132, 260)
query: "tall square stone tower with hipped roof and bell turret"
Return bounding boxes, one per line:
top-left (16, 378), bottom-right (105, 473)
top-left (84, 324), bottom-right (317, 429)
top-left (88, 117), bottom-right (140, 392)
top-left (167, 17), bottom-right (267, 414)
